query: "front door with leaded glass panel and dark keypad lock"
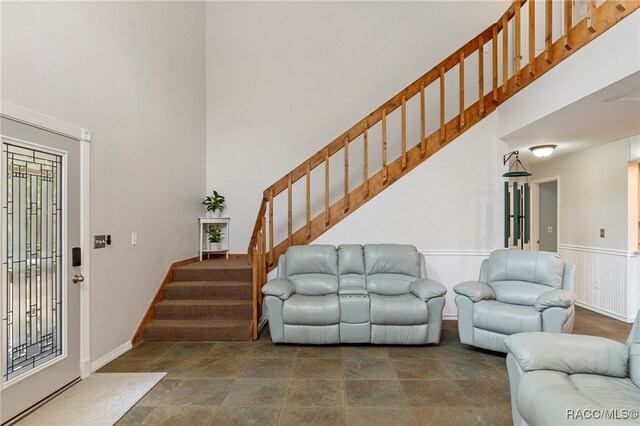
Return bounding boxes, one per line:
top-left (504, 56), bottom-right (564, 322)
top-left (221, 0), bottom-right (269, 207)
top-left (0, 118), bottom-right (82, 422)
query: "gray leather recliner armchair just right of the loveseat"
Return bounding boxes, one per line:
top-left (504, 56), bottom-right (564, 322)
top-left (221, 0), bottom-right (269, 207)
top-left (453, 249), bottom-right (575, 352)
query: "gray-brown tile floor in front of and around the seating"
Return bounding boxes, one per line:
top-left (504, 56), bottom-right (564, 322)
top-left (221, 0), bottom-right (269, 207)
top-left (100, 309), bottom-right (630, 425)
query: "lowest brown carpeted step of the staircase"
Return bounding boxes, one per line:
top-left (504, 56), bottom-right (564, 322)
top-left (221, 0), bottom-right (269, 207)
top-left (144, 319), bottom-right (251, 342)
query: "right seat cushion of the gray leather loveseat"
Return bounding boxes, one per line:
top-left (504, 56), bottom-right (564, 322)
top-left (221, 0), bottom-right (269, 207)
top-left (369, 293), bottom-right (429, 325)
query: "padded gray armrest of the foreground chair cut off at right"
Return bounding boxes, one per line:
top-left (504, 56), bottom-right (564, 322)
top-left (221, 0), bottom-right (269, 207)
top-left (504, 331), bottom-right (629, 377)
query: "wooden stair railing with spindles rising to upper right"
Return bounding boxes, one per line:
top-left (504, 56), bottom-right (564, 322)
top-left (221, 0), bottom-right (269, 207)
top-left (248, 0), bottom-right (640, 339)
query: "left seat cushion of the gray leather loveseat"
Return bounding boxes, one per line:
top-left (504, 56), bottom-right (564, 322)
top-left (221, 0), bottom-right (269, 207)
top-left (282, 294), bottom-right (340, 325)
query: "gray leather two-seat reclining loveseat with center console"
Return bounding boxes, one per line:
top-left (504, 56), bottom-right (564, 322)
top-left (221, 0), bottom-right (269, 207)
top-left (262, 244), bottom-right (447, 345)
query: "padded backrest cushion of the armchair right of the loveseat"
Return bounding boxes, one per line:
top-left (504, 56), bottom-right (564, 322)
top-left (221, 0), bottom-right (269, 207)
top-left (487, 249), bottom-right (564, 288)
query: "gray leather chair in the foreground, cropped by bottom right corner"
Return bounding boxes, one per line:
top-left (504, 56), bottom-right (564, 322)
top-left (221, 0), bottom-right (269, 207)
top-left (505, 312), bottom-right (640, 425)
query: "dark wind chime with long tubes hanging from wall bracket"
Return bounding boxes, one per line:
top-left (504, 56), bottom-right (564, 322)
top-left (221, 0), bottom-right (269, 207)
top-left (502, 151), bottom-right (531, 248)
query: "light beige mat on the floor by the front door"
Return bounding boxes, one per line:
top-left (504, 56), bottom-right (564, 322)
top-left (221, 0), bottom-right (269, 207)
top-left (17, 373), bottom-right (167, 426)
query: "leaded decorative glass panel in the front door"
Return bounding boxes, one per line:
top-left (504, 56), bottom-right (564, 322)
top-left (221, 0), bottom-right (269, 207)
top-left (2, 141), bottom-right (65, 382)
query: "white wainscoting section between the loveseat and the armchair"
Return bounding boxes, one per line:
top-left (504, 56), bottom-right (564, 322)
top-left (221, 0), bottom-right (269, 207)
top-left (420, 250), bottom-right (491, 319)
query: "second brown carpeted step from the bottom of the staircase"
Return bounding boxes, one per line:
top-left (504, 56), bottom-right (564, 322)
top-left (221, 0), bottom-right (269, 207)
top-left (155, 299), bottom-right (253, 320)
